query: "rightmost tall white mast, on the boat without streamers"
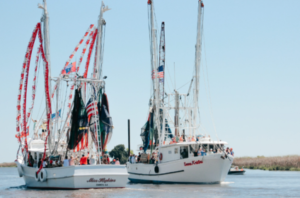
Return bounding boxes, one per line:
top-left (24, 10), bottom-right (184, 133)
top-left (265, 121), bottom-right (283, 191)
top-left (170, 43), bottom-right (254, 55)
top-left (192, 0), bottom-right (204, 136)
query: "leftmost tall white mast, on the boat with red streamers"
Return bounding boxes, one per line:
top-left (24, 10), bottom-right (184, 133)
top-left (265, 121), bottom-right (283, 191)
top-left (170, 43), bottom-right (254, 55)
top-left (38, 0), bottom-right (53, 151)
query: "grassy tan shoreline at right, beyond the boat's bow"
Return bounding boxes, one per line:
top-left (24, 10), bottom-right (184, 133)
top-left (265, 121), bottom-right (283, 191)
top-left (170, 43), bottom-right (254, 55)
top-left (232, 155), bottom-right (300, 171)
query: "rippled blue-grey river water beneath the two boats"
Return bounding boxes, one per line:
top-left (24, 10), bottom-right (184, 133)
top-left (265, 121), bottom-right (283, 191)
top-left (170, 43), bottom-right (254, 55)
top-left (0, 168), bottom-right (300, 198)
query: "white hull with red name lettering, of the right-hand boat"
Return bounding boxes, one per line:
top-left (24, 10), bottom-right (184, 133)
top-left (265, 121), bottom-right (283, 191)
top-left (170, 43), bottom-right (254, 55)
top-left (127, 154), bottom-right (233, 184)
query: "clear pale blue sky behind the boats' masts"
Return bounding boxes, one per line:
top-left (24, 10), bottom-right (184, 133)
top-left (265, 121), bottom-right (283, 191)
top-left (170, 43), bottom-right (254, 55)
top-left (0, 0), bottom-right (300, 162)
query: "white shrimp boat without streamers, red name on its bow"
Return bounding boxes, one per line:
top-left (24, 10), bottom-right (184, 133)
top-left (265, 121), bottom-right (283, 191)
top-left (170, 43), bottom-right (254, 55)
top-left (127, 0), bottom-right (233, 184)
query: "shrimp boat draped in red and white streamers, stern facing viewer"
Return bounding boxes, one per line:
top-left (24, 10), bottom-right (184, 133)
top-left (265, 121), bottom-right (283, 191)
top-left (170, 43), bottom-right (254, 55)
top-left (15, 0), bottom-right (128, 189)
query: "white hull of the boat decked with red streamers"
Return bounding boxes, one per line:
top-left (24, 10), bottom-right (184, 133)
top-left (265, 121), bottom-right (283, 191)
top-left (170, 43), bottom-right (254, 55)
top-left (16, 162), bottom-right (128, 189)
